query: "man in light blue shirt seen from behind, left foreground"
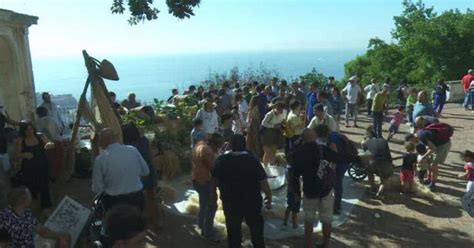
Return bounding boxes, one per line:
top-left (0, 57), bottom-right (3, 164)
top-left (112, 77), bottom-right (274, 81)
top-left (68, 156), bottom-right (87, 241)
top-left (92, 128), bottom-right (150, 210)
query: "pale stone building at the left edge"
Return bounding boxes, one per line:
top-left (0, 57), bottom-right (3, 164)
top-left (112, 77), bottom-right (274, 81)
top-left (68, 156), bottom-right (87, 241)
top-left (0, 9), bottom-right (38, 120)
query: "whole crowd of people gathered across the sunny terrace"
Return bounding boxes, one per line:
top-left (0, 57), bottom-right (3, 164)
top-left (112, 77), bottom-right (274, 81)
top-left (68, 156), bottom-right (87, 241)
top-left (0, 70), bottom-right (474, 248)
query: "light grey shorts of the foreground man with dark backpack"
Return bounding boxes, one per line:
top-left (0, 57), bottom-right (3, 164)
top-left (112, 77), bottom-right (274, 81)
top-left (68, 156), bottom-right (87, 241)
top-left (303, 190), bottom-right (334, 224)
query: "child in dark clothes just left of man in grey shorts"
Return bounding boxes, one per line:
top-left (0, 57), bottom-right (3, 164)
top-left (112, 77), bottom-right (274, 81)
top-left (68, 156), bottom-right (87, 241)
top-left (283, 165), bottom-right (301, 229)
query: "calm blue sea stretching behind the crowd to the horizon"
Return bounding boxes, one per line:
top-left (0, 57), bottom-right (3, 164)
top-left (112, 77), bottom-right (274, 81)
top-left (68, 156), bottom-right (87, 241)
top-left (33, 50), bottom-right (363, 101)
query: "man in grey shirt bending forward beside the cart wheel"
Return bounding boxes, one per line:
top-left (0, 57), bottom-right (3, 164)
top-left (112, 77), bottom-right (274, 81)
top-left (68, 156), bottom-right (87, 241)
top-left (362, 137), bottom-right (393, 198)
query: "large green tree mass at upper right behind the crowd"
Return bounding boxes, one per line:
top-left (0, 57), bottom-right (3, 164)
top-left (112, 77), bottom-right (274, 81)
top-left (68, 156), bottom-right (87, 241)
top-left (345, 0), bottom-right (474, 85)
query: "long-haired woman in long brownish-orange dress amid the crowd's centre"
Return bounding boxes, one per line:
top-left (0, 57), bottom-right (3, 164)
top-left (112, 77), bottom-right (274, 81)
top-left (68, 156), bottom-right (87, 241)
top-left (247, 96), bottom-right (262, 158)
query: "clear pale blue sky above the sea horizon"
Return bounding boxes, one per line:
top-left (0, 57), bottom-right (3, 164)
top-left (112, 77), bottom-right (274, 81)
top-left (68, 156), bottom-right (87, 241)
top-left (0, 0), bottom-right (474, 57)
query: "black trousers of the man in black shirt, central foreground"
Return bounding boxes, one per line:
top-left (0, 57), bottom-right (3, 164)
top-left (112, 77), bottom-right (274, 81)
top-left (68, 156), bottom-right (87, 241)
top-left (224, 206), bottom-right (265, 248)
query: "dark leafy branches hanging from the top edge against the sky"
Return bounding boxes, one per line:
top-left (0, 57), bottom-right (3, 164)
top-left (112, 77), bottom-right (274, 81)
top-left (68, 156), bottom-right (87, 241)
top-left (110, 0), bottom-right (201, 25)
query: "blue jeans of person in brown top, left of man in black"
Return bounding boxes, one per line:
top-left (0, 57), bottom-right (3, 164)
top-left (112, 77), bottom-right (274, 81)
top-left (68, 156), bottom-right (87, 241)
top-left (193, 181), bottom-right (217, 236)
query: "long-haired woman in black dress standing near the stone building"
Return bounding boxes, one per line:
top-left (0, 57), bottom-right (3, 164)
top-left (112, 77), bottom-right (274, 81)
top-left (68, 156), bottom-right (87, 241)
top-left (16, 121), bottom-right (54, 209)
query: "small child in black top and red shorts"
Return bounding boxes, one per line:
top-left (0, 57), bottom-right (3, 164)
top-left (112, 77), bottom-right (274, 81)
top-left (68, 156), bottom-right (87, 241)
top-left (400, 142), bottom-right (417, 193)
